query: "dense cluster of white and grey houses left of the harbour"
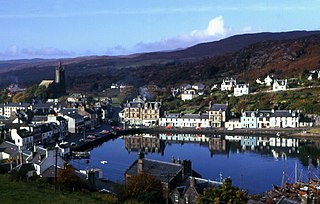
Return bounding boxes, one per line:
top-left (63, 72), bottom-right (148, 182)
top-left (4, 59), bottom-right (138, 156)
top-left (0, 94), bottom-right (111, 177)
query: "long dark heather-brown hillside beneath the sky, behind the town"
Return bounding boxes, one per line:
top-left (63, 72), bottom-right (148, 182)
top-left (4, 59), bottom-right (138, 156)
top-left (0, 31), bottom-right (320, 91)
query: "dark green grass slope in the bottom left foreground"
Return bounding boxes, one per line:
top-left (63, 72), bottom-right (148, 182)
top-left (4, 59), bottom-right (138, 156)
top-left (0, 175), bottom-right (115, 204)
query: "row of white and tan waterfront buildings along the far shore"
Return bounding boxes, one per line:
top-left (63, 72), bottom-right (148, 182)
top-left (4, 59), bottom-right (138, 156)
top-left (119, 97), bottom-right (313, 129)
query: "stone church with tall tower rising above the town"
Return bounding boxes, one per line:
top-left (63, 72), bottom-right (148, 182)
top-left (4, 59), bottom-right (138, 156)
top-left (39, 61), bottom-right (66, 98)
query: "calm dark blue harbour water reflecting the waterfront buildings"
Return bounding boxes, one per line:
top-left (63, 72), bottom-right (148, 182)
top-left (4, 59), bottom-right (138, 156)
top-left (71, 134), bottom-right (320, 194)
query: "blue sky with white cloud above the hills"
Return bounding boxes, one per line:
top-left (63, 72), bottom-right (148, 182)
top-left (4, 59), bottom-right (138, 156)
top-left (0, 0), bottom-right (320, 60)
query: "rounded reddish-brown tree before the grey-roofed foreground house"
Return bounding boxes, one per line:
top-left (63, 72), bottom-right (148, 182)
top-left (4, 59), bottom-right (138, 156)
top-left (125, 171), bottom-right (164, 203)
